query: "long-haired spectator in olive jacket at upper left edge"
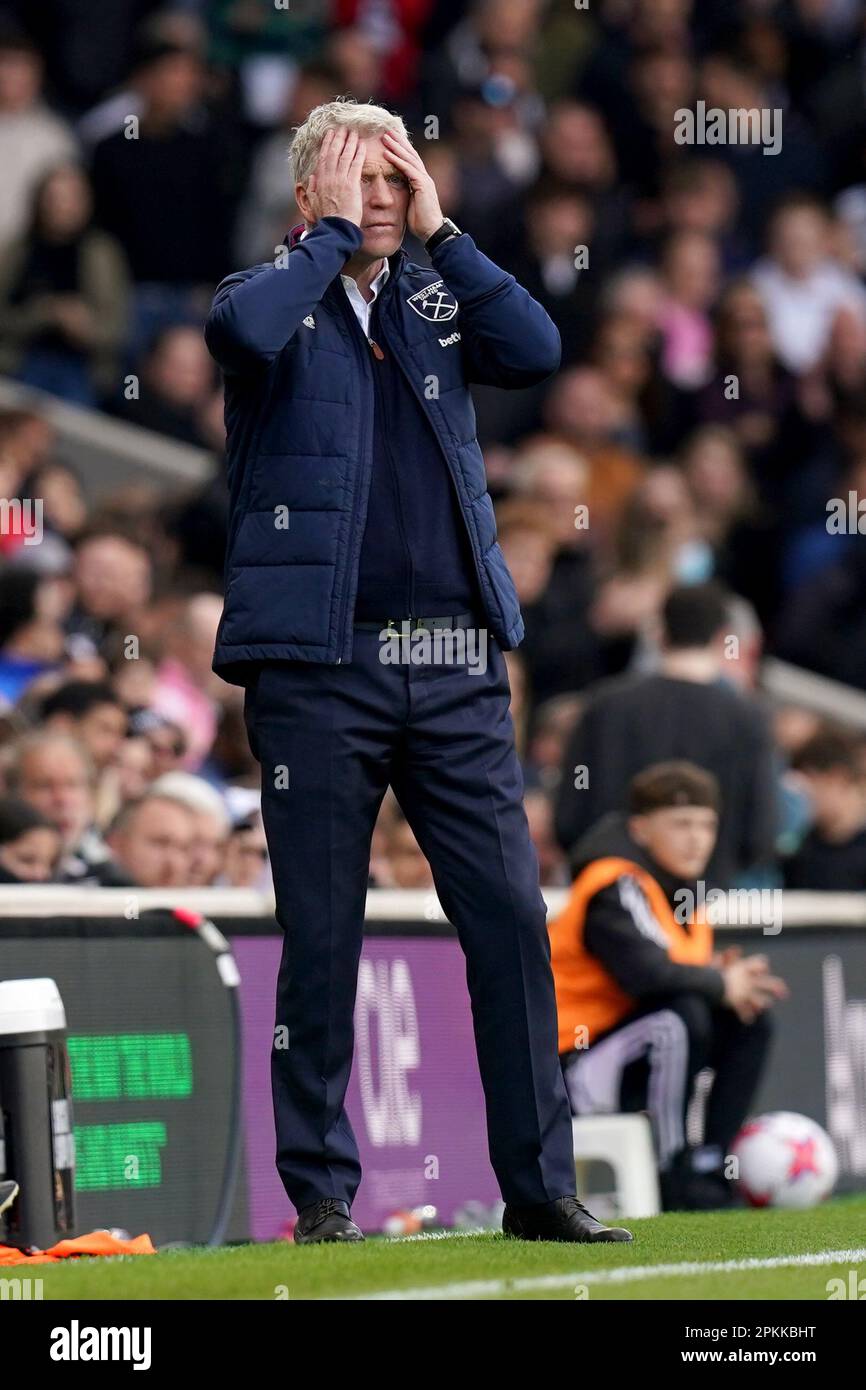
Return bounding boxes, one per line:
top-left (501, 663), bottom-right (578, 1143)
top-left (0, 165), bottom-right (128, 406)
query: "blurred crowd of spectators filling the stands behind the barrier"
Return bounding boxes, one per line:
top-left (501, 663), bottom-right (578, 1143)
top-left (0, 0), bottom-right (866, 888)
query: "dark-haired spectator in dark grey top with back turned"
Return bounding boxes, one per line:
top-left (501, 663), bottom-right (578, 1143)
top-left (556, 584), bottom-right (778, 887)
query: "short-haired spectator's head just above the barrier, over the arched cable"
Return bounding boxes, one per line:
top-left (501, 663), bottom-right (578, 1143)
top-left (101, 791), bottom-right (196, 888)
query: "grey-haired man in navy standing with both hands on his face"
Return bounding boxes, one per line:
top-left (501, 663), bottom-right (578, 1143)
top-left (206, 100), bottom-right (631, 1243)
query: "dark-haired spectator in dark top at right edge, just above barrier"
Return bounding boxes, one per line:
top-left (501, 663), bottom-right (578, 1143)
top-left (781, 727), bottom-right (866, 892)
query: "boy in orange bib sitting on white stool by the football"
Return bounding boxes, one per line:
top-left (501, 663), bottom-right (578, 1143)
top-left (549, 762), bottom-right (788, 1211)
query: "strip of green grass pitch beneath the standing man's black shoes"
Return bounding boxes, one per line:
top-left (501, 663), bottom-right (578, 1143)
top-left (23, 1194), bottom-right (866, 1301)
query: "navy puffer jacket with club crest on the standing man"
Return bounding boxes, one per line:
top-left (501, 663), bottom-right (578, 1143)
top-left (204, 217), bottom-right (560, 685)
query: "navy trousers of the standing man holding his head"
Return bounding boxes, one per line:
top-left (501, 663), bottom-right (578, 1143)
top-left (245, 630), bottom-right (574, 1209)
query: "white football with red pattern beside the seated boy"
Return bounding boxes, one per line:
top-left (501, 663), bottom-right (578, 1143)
top-left (731, 1111), bottom-right (840, 1207)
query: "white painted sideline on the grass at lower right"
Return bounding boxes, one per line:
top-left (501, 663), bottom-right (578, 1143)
top-left (341, 1248), bottom-right (866, 1302)
